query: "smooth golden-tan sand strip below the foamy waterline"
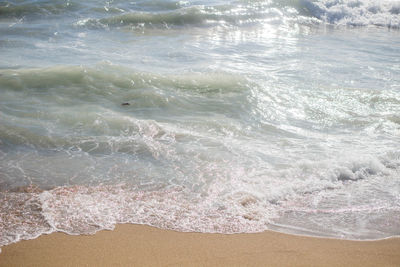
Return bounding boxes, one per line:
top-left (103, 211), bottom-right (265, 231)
top-left (0, 225), bottom-right (400, 267)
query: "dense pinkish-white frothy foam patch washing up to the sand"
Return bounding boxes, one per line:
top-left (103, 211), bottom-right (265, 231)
top-left (39, 185), bottom-right (280, 234)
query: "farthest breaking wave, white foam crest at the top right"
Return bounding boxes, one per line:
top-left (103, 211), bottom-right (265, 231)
top-left (77, 0), bottom-right (400, 28)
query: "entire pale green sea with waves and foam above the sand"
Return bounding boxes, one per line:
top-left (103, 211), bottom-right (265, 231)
top-left (0, 0), bottom-right (400, 251)
